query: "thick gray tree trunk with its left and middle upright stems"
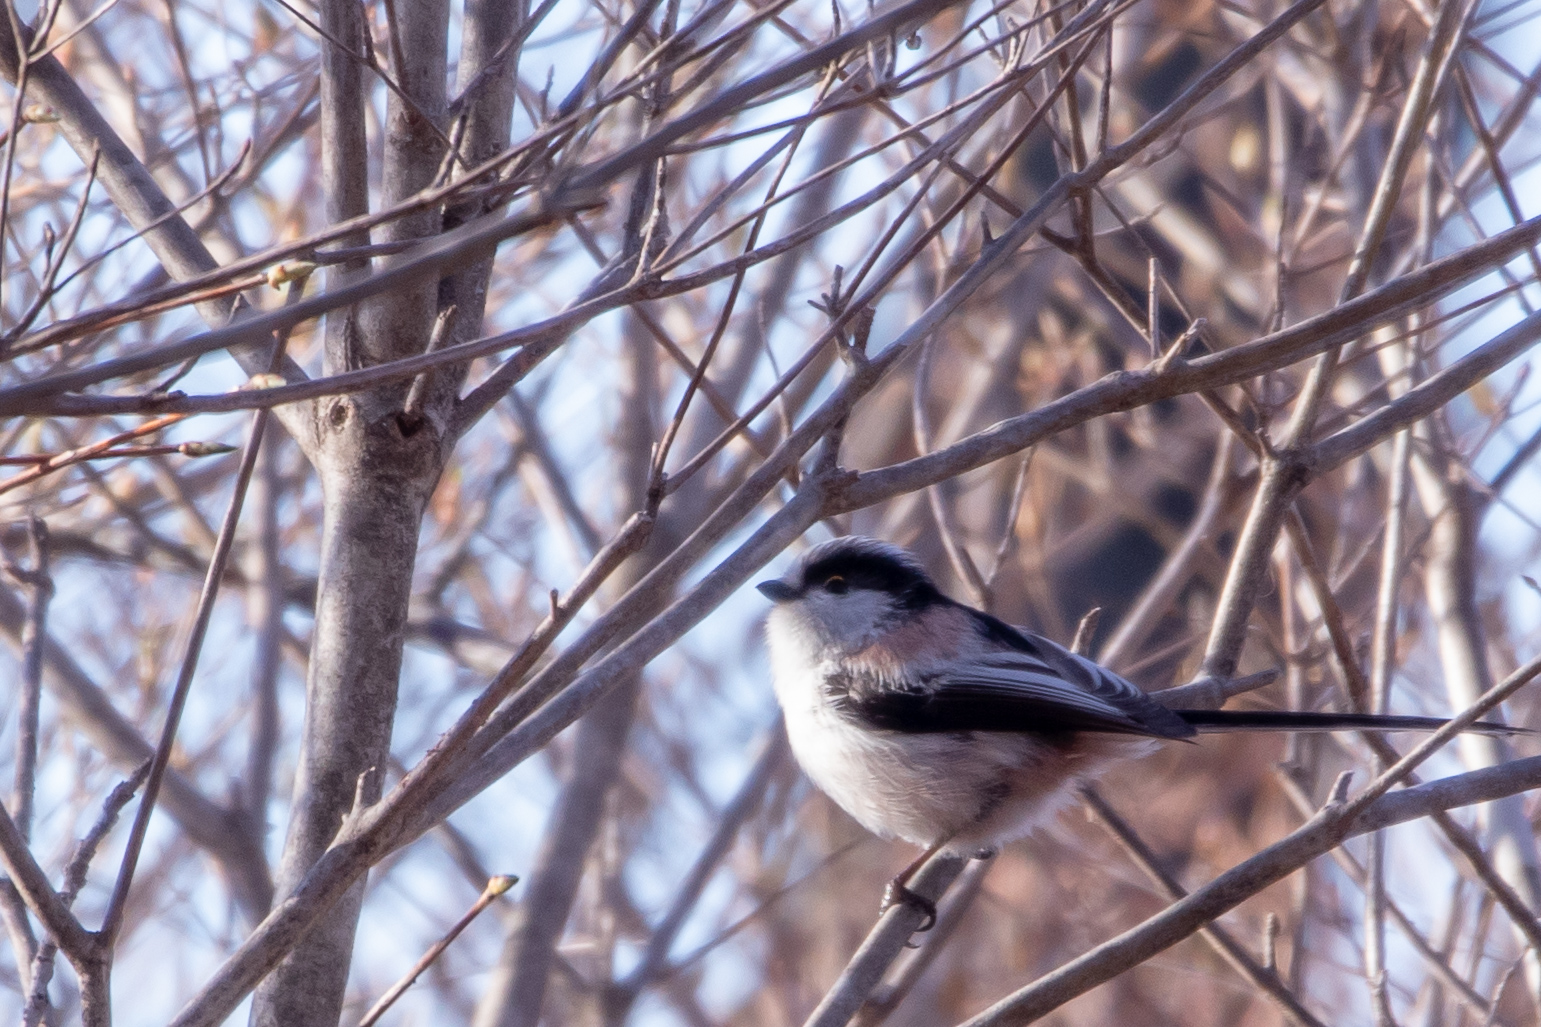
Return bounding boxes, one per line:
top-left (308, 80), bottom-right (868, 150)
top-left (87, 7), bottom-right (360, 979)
top-left (251, 0), bottom-right (448, 1027)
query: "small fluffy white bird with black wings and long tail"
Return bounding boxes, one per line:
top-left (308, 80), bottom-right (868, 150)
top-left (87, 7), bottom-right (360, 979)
top-left (757, 535), bottom-right (1512, 930)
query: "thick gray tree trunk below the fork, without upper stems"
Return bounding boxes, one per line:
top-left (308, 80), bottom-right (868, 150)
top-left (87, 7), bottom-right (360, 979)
top-left (251, 399), bottom-right (441, 1027)
